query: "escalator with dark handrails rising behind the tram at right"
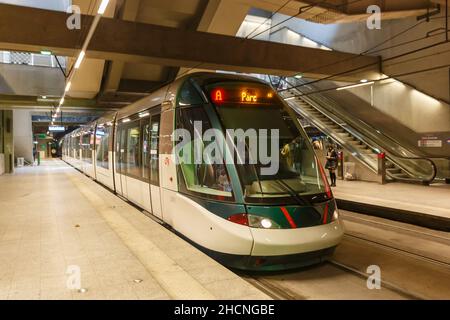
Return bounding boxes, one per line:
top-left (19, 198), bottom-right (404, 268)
top-left (274, 78), bottom-right (442, 185)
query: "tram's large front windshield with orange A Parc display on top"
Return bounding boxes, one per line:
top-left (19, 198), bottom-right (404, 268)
top-left (208, 82), bottom-right (326, 203)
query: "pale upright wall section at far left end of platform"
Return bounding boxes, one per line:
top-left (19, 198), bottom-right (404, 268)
top-left (14, 110), bottom-right (33, 163)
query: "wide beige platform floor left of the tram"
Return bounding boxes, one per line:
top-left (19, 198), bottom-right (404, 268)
top-left (0, 160), bottom-right (269, 300)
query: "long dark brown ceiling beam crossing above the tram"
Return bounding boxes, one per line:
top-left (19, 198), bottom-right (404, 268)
top-left (0, 4), bottom-right (379, 80)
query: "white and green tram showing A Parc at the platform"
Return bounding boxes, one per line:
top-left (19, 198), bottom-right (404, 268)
top-left (63, 73), bottom-right (343, 270)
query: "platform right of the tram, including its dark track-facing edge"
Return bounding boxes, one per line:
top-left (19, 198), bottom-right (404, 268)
top-left (333, 180), bottom-right (450, 229)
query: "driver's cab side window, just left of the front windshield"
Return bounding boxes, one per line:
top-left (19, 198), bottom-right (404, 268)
top-left (177, 106), bottom-right (233, 200)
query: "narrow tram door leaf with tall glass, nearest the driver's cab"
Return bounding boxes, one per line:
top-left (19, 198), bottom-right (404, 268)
top-left (149, 113), bottom-right (162, 219)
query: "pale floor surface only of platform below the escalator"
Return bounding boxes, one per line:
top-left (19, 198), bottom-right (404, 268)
top-left (333, 180), bottom-right (450, 218)
